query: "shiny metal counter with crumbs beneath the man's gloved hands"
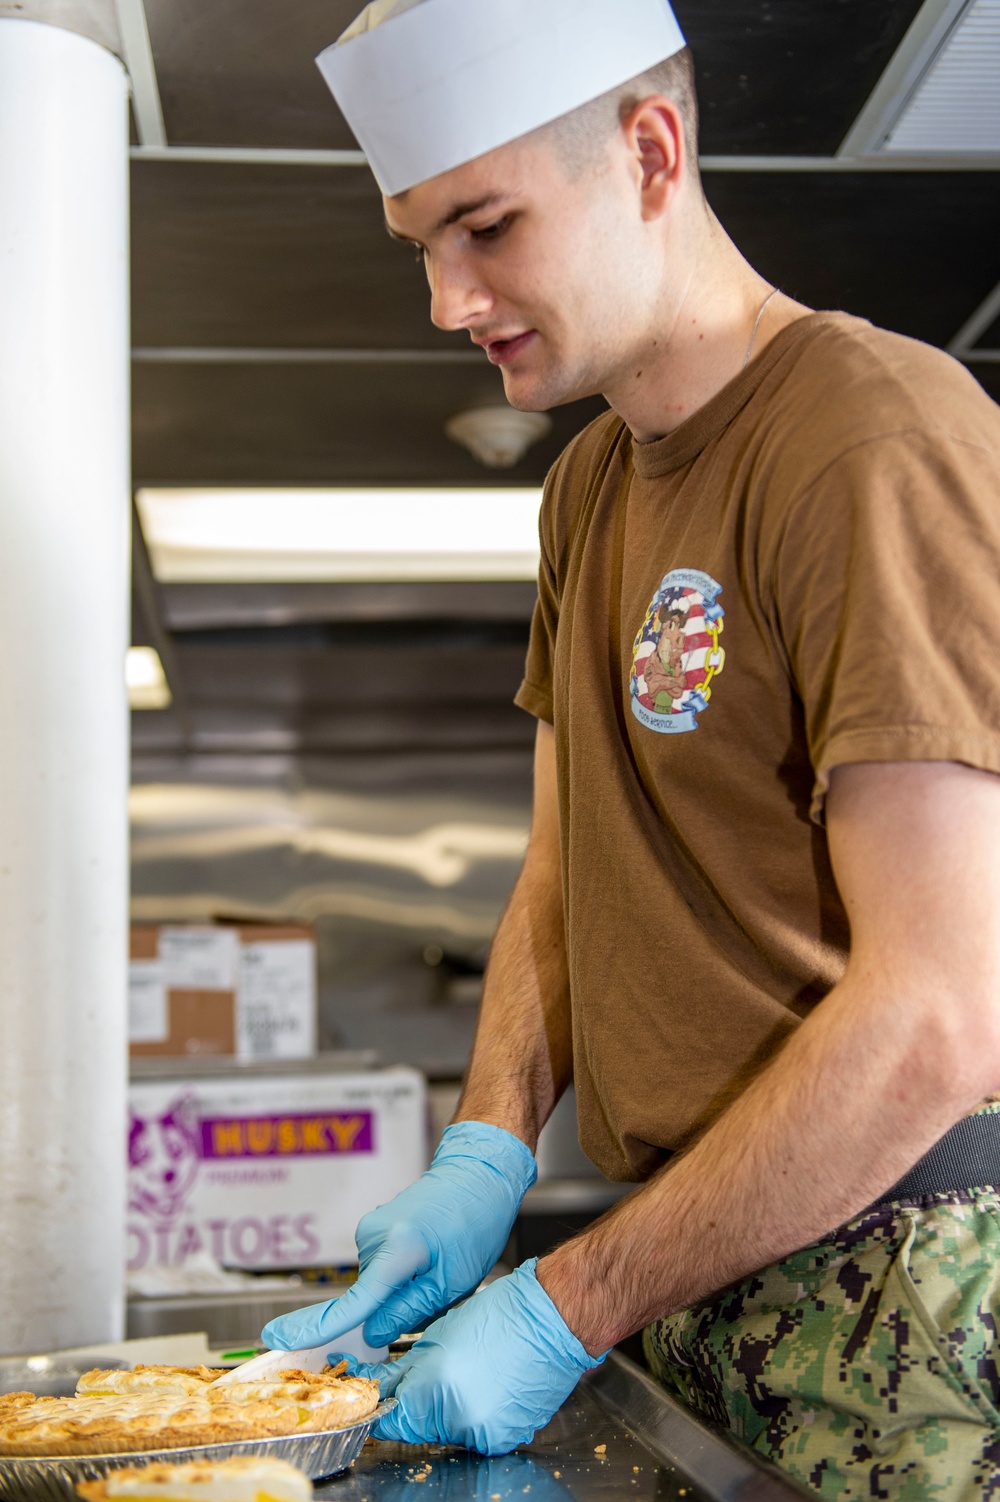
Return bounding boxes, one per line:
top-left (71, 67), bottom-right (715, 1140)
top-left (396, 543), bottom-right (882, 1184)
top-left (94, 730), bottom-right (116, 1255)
top-left (317, 1352), bottom-right (815, 1502)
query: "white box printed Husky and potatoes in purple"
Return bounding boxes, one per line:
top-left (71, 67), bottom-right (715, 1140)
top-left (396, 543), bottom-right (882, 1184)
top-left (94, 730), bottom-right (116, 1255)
top-left (128, 1068), bottom-right (428, 1271)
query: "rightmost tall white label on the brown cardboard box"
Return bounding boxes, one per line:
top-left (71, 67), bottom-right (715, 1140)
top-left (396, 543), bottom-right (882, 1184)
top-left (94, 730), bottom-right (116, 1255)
top-left (236, 939), bottom-right (315, 1059)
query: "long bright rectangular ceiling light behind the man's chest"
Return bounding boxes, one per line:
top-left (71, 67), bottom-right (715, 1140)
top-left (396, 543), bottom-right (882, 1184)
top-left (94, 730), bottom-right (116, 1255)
top-left (135, 487), bottom-right (542, 583)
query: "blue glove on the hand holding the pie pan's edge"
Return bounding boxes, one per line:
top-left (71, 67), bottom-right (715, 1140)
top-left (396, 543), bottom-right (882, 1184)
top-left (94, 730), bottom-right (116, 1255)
top-left (330, 1259), bottom-right (607, 1455)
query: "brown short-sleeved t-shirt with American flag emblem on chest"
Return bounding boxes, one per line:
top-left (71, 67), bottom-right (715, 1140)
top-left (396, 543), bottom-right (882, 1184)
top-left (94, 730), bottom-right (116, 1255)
top-left (517, 312), bottom-right (1000, 1179)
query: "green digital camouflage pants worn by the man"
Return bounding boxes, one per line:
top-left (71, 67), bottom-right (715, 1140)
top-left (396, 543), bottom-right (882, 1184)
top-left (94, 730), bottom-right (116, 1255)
top-left (646, 1188), bottom-right (1000, 1502)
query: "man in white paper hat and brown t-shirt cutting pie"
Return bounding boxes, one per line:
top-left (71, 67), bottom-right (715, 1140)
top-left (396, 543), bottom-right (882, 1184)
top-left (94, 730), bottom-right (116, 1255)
top-left (264, 0), bottom-right (1000, 1499)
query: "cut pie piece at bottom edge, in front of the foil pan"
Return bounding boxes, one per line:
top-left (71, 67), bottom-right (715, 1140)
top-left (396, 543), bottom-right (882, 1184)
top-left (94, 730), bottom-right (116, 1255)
top-left (77, 1457), bottom-right (312, 1502)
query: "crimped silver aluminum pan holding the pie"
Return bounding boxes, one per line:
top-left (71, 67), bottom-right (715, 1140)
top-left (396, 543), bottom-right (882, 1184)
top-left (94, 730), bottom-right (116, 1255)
top-left (0, 1398), bottom-right (396, 1502)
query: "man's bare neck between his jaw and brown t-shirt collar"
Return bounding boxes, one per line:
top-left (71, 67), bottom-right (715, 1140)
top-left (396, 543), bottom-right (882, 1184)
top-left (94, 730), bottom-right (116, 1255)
top-left (604, 225), bottom-right (811, 443)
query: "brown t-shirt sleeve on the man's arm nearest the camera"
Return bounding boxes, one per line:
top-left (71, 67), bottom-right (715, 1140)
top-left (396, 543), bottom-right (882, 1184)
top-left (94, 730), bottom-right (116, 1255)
top-left (773, 433), bottom-right (1000, 823)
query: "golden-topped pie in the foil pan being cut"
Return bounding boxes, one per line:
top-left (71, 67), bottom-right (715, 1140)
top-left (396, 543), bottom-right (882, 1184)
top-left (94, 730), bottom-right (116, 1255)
top-left (0, 1362), bottom-right (378, 1455)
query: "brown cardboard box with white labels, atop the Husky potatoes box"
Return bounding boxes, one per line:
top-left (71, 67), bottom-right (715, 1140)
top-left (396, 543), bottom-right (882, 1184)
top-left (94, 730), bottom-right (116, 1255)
top-left (129, 924), bottom-right (317, 1059)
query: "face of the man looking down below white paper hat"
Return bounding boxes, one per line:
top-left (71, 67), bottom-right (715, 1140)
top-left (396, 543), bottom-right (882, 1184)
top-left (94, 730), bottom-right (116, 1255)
top-left (384, 134), bottom-right (650, 412)
